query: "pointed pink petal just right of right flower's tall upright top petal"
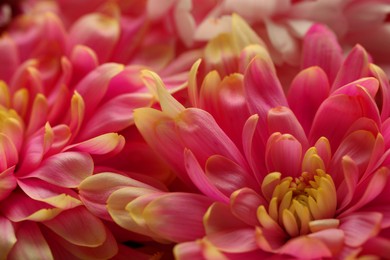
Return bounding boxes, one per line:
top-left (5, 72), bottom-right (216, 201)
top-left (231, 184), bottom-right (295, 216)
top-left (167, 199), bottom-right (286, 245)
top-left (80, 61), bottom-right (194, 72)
top-left (331, 45), bottom-right (369, 92)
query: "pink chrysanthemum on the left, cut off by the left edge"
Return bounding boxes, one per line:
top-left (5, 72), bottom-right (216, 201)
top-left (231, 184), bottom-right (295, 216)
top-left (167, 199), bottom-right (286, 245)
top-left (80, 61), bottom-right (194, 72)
top-left (0, 1), bottom-right (189, 259)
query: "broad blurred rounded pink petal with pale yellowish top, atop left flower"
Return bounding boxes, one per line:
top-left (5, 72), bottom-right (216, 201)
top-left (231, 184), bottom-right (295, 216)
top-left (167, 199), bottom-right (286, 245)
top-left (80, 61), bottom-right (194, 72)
top-left (69, 13), bottom-right (120, 63)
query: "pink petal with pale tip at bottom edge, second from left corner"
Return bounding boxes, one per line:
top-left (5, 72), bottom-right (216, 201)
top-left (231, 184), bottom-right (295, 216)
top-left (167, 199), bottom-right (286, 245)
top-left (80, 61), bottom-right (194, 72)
top-left (8, 221), bottom-right (53, 259)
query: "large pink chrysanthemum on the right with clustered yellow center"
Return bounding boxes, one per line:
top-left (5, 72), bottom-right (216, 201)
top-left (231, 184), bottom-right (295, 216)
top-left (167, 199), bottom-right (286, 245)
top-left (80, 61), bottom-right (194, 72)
top-left (79, 15), bottom-right (390, 259)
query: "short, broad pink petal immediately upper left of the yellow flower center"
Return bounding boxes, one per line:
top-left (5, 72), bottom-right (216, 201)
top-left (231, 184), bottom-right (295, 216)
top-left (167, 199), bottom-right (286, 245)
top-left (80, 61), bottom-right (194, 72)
top-left (206, 155), bottom-right (258, 197)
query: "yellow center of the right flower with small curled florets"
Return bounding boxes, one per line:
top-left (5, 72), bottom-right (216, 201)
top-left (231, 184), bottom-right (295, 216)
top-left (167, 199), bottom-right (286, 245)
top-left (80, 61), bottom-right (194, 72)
top-left (257, 138), bottom-right (339, 237)
